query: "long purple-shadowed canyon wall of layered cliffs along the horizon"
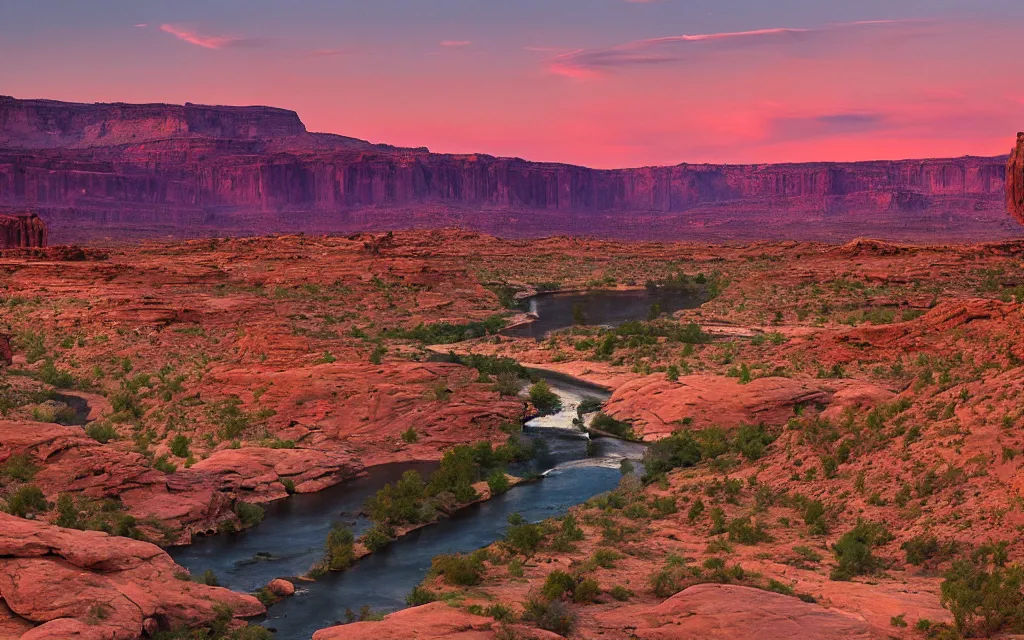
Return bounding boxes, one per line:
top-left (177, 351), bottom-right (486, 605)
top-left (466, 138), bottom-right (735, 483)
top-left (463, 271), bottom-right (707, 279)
top-left (0, 98), bottom-right (1016, 241)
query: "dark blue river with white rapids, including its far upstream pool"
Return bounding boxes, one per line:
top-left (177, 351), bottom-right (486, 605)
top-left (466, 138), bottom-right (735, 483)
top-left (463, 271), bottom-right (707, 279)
top-left (170, 290), bottom-right (699, 640)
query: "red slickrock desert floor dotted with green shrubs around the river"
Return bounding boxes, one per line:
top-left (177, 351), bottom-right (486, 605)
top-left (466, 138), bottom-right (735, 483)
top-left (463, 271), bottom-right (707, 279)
top-left (8, 230), bottom-right (1024, 640)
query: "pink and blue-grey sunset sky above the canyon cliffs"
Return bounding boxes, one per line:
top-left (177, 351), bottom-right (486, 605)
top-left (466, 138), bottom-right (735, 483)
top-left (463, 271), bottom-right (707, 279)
top-left (0, 0), bottom-right (1024, 168)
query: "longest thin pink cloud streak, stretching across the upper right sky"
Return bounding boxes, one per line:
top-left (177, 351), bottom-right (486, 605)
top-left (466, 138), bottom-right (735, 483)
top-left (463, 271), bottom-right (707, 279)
top-left (546, 20), bottom-right (934, 78)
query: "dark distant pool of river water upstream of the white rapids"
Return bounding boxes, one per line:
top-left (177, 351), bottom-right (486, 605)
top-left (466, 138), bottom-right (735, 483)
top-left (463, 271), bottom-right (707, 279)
top-left (502, 289), bottom-right (703, 340)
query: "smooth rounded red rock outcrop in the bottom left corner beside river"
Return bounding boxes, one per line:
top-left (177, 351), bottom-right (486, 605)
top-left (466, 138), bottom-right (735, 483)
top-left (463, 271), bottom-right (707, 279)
top-left (0, 513), bottom-right (264, 640)
